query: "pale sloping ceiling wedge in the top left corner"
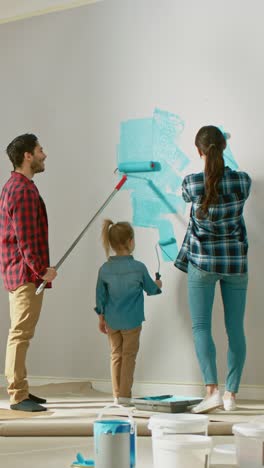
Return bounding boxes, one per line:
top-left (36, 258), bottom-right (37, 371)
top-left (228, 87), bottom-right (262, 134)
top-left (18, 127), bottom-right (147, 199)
top-left (0, 0), bottom-right (102, 23)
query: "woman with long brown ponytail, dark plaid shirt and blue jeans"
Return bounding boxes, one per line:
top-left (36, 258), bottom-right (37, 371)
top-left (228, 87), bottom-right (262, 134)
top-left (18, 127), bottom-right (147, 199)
top-left (175, 125), bottom-right (251, 413)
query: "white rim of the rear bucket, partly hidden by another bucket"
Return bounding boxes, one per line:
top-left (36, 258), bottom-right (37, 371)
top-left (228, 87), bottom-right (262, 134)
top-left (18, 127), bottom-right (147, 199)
top-left (148, 413), bottom-right (208, 433)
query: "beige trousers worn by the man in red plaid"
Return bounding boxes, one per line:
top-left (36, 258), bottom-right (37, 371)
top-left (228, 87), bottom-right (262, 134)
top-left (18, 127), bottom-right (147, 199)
top-left (5, 283), bottom-right (43, 404)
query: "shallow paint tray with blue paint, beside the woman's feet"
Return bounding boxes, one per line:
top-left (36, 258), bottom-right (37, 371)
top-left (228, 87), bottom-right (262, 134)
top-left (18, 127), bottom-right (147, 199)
top-left (131, 395), bottom-right (202, 413)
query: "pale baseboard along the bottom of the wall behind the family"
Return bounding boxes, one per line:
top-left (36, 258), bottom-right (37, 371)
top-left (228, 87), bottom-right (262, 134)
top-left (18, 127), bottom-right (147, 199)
top-left (0, 375), bottom-right (264, 400)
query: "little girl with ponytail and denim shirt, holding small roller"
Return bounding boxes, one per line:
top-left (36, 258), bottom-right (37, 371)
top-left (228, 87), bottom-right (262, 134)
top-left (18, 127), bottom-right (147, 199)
top-left (95, 219), bottom-right (162, 404)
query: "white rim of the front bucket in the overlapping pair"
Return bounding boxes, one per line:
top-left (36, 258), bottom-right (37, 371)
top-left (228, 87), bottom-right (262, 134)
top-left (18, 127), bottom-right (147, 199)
top-left (155, 434), bottom-right (212, 452)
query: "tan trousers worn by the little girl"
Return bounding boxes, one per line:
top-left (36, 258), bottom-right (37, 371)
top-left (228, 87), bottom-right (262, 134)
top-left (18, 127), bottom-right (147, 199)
top-left (107, 326), bottom-right (142, 398)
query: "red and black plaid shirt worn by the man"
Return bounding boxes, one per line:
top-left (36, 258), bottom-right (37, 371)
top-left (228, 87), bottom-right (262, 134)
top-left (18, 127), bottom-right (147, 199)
top-left (0, 172), bottom-right (49, 291)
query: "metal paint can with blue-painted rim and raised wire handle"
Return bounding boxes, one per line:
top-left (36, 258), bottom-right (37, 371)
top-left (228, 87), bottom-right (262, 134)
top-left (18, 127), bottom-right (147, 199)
top-left (93, 405), bottom-right (136, 468)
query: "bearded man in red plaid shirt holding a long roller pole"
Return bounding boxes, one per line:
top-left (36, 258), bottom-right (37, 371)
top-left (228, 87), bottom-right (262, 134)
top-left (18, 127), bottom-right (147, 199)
top-left (0, 134), bottom-right (57, 411)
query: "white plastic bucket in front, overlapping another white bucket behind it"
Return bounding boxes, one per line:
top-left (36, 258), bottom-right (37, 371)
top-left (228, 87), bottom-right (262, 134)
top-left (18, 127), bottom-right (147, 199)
top-left (152, 434), bottom-right (212, 468)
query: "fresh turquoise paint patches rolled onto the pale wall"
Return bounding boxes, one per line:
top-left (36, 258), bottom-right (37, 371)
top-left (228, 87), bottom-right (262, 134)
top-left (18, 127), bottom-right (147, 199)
top-left (117, 109), bottom-right (238, 261)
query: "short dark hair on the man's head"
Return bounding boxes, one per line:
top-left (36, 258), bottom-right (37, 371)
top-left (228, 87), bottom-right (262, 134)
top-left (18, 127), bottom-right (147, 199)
top-left (6, 133), bottom-right (38, 169)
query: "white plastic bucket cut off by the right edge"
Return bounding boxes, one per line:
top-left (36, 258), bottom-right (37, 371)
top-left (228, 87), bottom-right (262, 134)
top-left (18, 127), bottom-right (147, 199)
top-left (232, 418), bottom-right (264, 468)
